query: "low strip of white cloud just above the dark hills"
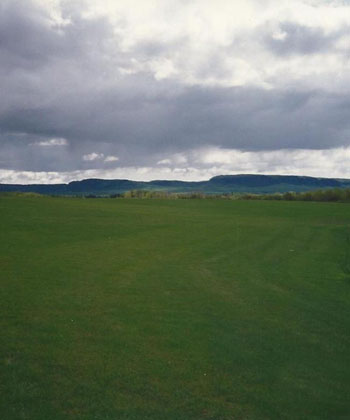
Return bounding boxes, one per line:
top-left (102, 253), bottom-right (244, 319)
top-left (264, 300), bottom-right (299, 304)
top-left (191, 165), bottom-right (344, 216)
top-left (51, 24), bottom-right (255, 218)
top-left (0, 148), bottom-right (350, 184)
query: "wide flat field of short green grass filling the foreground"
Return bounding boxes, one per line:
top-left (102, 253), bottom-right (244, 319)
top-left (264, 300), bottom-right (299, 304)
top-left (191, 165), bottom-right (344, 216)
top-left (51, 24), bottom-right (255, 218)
top-left (0, 197), bottom-right (350, 420)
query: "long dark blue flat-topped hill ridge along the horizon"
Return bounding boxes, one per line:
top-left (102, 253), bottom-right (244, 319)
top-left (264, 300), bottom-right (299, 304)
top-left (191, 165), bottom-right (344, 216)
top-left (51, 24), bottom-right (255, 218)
top-left (0, 175), bottom-right (350, 195)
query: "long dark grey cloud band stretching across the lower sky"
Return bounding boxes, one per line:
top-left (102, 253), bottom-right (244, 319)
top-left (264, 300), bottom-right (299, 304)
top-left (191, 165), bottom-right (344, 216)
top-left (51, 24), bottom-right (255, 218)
top-left (0, 84), bottom-right (350, 170)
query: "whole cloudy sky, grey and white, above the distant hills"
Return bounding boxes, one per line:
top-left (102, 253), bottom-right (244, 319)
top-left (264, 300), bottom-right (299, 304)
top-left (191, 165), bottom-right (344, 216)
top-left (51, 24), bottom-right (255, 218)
top-left (0, 0), bottom-right (350, 183)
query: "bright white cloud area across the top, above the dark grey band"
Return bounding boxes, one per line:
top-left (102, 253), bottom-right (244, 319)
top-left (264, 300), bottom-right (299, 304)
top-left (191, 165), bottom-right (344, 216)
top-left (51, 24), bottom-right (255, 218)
top-left (30, 0), bottom-right (350, 88)
